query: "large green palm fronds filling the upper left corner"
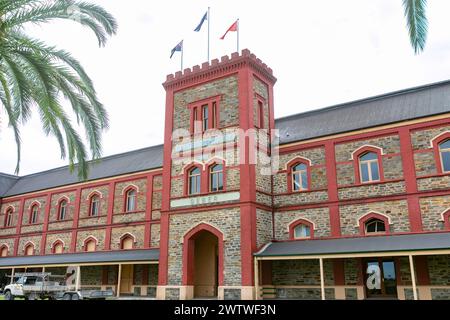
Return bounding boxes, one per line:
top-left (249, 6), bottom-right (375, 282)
top-left (0, 0), bottom-right (117, 179)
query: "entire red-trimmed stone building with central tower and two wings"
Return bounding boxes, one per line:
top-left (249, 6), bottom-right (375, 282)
top-left (0, 50), bottom-right (450, 299)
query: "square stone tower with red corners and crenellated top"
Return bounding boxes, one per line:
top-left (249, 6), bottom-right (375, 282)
top-left (157, 50), bottom-right (276, 299)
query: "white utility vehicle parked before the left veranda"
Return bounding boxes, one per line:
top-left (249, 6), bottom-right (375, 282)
top-left (4, 272), bottom-right (114, 300)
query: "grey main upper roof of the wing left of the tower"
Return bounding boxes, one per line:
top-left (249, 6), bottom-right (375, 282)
top-left (0, 145), bottom-right (163, 197)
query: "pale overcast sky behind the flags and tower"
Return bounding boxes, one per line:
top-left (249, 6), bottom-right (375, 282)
top-left (0, 0), bottom-right (450, 175)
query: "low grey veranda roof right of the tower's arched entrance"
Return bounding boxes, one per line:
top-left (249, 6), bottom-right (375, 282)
top-left (255, 232), bottom-right (450, 257)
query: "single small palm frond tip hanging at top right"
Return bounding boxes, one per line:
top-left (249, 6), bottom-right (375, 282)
top-left (403, 0), bottom-right (428, 54)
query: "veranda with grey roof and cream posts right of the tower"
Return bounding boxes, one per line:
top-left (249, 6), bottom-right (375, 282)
top-left (255, 233), bottom-right (450, 300)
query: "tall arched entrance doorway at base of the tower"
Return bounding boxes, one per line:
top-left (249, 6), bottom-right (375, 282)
top-left (183, 224), bottom-right (223, 298)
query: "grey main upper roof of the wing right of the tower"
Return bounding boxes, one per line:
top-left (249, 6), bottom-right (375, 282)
top-left (275, 80), bottom-right (450, 144)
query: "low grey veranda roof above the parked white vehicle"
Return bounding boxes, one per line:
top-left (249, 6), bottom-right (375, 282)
top-left (0, 249), bottom-right (159, 267)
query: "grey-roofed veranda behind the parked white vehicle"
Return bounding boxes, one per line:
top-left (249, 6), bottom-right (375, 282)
top-left (0, 250), bottom-right (158, 298)
